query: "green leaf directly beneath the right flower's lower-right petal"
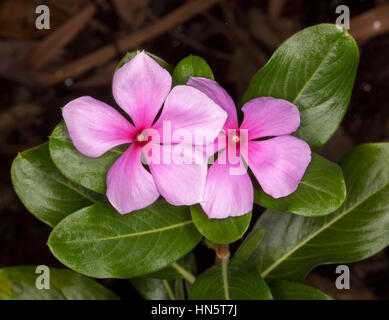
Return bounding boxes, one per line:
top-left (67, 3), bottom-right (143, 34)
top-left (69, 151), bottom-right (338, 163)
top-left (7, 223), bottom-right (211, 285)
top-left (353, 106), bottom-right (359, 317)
top-left (254, 153), bottom-right (346, 216)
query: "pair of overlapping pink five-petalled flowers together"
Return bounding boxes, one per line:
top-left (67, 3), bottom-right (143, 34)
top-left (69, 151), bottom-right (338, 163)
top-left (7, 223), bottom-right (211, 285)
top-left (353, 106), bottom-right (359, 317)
top-left (62, 52), bottom-right (311, 218)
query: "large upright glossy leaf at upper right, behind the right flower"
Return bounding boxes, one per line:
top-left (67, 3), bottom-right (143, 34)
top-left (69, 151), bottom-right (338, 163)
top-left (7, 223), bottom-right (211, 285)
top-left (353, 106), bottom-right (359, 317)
top-left (242, 24), bottom-right (359, 149)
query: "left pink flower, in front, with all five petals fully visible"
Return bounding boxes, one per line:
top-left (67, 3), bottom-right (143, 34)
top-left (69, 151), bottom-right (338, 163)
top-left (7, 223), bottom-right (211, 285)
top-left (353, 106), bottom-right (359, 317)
top-left (62, 52), bottom-right (227, 213)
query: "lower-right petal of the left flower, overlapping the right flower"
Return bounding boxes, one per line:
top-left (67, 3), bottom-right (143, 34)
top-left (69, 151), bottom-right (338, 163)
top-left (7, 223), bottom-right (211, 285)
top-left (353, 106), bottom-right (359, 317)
top-left (149, 145), bottom-right (207, 206)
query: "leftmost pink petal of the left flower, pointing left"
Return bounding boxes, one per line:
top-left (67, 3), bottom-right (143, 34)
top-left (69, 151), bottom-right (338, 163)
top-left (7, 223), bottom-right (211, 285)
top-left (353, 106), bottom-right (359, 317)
top-left (62, 97), bottom-right (136, 158)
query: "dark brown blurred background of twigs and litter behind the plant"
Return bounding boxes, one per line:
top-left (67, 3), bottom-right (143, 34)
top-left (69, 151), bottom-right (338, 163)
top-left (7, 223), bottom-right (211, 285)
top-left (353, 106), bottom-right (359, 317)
top-left (0, 0), bottom-right (389, 299)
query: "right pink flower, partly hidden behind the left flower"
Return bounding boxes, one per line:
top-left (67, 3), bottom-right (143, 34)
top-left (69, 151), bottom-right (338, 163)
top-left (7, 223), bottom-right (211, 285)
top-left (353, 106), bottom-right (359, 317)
top-left (187, 78), bottom-right (311, 219)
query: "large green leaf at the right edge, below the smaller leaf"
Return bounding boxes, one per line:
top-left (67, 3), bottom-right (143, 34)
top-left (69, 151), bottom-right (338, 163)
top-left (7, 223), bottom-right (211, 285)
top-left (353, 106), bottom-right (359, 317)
top-left (235, 143), bottom-right (389, 281)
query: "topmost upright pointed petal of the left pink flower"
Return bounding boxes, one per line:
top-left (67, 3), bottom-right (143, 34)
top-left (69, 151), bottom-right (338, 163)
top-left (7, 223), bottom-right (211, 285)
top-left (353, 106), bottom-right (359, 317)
top-left (112, 52), bottom-right (172, 131)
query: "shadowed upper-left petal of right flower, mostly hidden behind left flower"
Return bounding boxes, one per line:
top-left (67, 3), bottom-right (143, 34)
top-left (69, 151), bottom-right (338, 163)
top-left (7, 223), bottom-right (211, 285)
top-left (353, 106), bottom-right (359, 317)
top-left (187, 77), bottom-right (238, 131)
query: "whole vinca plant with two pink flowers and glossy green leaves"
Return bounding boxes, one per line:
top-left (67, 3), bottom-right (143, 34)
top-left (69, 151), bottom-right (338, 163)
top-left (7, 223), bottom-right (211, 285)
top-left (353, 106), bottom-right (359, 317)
top-left (0, 24), bottom-right (389, 300)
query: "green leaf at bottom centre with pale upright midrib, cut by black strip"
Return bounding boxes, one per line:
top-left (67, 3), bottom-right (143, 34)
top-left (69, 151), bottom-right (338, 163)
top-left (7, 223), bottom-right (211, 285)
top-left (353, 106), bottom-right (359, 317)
top-left (189, 260), bottom-right (272, 300)
